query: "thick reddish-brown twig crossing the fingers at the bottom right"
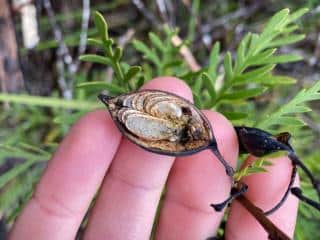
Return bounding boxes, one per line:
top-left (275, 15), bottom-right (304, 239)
top-left (237, 195), bottom-right (290, 240)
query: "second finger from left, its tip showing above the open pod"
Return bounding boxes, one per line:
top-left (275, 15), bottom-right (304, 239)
top-left (85, 77), bottom-right (192, 239)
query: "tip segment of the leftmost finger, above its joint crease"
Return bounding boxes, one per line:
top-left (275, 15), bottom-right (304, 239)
top-left (37, 110), bottom-right (121, 203)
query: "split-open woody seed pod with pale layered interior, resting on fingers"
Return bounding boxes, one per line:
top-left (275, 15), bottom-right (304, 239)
top-left (99, 90), bottom-right (216, 156)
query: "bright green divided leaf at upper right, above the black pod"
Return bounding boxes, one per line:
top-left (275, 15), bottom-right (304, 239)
top-left (197, 9), bottom-right (307, 119)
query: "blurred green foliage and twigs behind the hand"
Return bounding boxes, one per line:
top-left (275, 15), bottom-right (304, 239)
top-left (0, 0), bottom-right (320, 240)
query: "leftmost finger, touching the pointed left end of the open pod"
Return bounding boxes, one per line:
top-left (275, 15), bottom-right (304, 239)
top-left (10, 110), bottom-right (121, 240)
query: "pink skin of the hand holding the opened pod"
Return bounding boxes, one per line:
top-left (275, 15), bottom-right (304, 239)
top-left (9, 77), bottom-right (298, 240)
